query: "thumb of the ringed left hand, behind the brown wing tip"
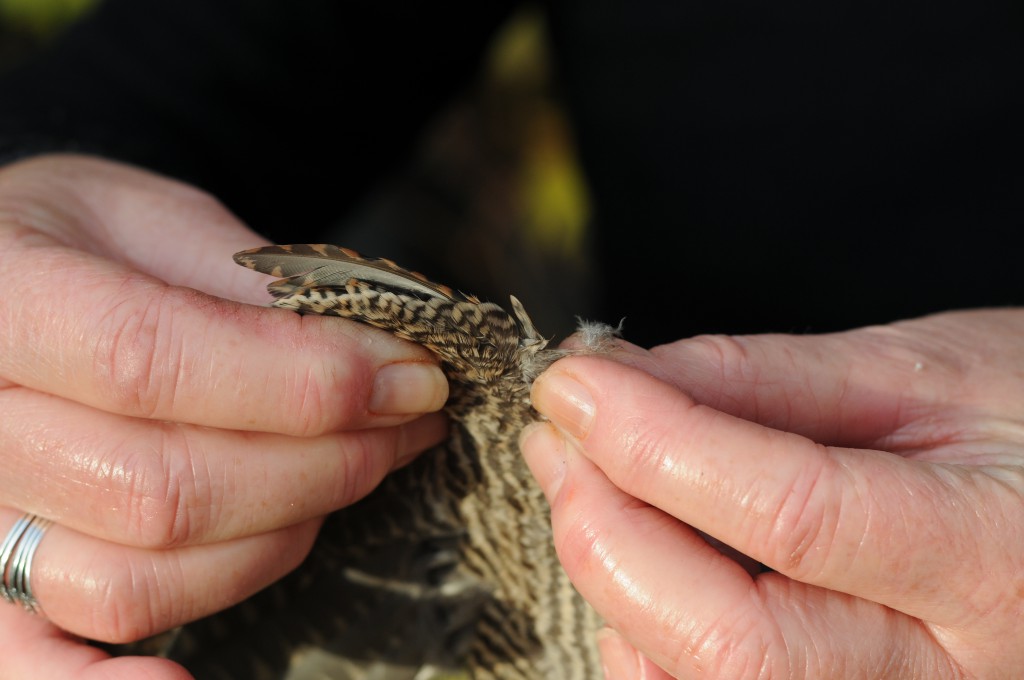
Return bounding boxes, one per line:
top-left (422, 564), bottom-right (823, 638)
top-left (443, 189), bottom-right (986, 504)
top-left (0, 154), bottom-right (268, 304)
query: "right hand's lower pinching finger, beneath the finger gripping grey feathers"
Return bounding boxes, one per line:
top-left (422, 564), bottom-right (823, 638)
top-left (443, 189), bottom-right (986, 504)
top-left (523, 425), bottom-right (952, 678)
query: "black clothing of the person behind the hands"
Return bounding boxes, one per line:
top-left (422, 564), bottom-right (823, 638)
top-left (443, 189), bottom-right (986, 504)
top-left (0, 0), bottom-right (1024, 343)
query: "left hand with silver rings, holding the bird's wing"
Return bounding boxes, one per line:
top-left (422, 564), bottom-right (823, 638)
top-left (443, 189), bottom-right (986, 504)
top-left (0, 156), bottom-right (447, 679)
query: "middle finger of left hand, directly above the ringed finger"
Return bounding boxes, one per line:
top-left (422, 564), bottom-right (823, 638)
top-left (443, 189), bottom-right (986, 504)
top-left (0, 388), bottom-right (447, 548)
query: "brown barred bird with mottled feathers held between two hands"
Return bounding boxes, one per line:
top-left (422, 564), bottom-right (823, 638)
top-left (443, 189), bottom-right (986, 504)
top-left (144, 244), bottom-right (616, 680)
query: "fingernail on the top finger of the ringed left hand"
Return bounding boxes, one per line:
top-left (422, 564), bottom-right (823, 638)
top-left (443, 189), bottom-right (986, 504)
top-left (370, 363), bottom-right (447, 416)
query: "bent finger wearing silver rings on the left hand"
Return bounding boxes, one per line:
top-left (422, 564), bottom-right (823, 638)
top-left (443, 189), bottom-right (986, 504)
top-left (0, 508), bottom-right (321, 642)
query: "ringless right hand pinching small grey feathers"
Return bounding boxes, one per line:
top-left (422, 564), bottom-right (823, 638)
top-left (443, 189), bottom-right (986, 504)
top-left (523, 310), bottom-right (1024, 680)
